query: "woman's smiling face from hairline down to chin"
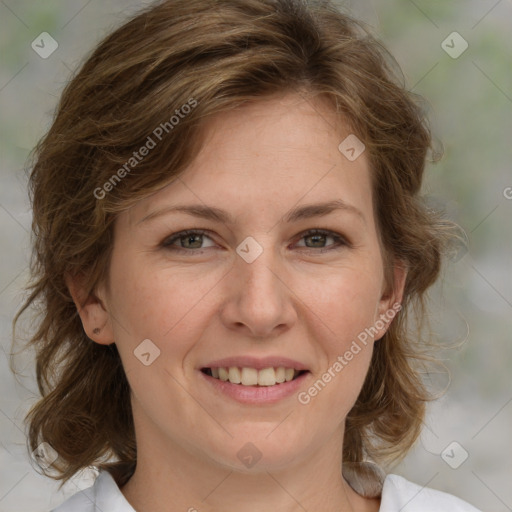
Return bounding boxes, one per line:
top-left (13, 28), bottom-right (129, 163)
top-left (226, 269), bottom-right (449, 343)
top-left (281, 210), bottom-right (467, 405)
top-left (82, 95), bottom-right (403, 471)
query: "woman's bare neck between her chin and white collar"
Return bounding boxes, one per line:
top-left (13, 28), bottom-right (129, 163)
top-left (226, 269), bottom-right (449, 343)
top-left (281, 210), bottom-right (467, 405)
top-left (121, 426), bottom-right (379, 512)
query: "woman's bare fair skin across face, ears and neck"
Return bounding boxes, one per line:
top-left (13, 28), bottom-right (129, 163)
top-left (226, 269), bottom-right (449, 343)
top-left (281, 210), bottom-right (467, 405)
top-left (69, 94), bottom-right (405, 512)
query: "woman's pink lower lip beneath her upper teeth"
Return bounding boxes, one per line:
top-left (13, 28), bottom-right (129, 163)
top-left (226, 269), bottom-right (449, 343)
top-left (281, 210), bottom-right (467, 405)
top-left (199, 370), bottom-right (310, 404)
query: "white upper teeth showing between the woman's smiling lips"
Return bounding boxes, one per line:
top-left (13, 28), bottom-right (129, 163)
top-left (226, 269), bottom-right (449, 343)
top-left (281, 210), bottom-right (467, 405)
top-left (201, 366), bottom-right (308, 386)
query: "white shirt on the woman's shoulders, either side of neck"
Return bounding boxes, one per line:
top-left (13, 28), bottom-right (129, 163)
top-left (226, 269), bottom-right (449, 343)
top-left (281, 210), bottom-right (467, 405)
top-left (51, 471), bottom-right (481, 512)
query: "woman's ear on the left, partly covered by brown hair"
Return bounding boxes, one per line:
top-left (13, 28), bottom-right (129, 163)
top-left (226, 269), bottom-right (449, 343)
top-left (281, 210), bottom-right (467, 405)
top-left (64, 274), bottom-right (114, 345)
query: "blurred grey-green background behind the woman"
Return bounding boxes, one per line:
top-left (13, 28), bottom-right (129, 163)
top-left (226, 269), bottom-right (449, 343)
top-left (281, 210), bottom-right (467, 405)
top-left (0, 0), bottom-right (512, 512)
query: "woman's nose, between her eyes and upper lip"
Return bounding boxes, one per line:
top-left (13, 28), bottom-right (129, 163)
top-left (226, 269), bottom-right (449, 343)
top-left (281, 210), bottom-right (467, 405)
top-left (220, 237), bottom-right (297, 339)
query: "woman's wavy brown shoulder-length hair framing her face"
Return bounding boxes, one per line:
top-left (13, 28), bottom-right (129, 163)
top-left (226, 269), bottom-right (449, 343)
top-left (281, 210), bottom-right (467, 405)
top-left (13, 0), bottom-right (448, 486)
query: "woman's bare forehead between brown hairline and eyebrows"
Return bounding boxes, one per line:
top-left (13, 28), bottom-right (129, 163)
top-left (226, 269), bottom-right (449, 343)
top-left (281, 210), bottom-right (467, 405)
top-left (130, 94), bottom-right (372, 228)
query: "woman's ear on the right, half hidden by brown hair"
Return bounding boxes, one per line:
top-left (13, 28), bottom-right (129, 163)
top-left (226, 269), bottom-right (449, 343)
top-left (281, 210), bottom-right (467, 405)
top-left (374, 261), bottom-right (408, 341)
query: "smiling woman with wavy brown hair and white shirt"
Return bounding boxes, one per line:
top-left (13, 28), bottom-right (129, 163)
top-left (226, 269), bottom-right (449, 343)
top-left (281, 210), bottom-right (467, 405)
top-left (15, 0), bottom-right (476, 512)
